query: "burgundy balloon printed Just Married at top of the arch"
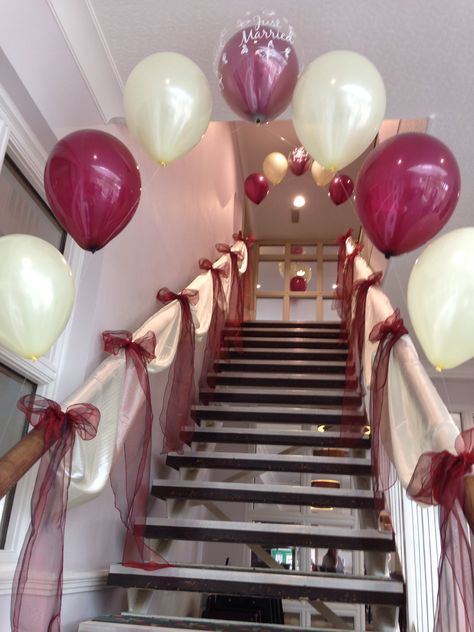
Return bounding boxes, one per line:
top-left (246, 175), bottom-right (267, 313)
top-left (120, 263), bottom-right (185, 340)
top-left (218, 26), bottom-right (299, 123)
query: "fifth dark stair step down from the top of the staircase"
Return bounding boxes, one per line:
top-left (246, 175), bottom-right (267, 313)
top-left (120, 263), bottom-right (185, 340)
top-left (214, 356), bottom-right (346, 375)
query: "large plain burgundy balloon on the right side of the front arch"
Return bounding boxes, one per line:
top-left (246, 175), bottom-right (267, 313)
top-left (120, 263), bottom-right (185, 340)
top-left (356, 133), bottom-right (461, 258)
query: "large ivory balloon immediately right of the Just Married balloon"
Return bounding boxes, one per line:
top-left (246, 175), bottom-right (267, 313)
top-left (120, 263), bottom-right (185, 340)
top-left (293, 50), bottom-right (386, 171)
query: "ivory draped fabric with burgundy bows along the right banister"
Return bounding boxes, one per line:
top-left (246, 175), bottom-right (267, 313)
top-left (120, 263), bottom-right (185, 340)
top-left (335, 232), bottom-right (474, 632)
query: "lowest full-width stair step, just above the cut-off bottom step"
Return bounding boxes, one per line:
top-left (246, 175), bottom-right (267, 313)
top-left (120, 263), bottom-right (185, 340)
top-left (108, 564), bottom-right (404, 606)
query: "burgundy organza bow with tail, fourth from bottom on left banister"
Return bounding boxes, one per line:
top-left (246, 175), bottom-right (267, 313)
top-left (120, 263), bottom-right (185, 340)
top-left (199, 259), bottom-right (230, 388)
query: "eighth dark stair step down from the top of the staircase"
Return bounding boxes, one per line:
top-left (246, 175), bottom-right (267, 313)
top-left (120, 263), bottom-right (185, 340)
top-left (192, 404), bottom-right (366, 425)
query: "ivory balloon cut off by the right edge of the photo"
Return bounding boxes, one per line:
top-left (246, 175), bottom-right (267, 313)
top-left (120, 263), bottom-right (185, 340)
top-left (408, 228), bottom-right (474, 370)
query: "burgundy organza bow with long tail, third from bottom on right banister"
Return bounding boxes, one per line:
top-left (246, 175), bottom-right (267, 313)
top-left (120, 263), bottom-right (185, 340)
top-left (340, 272), bottom-right (382, 444)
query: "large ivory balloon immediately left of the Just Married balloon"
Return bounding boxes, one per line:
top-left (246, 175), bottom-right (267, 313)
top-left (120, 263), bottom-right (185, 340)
top-left (123, 53), bottom-right (212, 165)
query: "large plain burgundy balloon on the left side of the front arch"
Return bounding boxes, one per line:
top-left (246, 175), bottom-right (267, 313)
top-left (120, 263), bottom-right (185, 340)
top-left (44, 129), bottom-right (141, 252)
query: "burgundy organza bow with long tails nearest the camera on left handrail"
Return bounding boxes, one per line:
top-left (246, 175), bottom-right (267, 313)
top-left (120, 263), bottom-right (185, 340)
top-left (11, 395), bottom-right (100, 632)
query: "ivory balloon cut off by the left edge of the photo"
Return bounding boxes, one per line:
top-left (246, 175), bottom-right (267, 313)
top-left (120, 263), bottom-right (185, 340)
top-left (0, 235), bottom-right (74, 359)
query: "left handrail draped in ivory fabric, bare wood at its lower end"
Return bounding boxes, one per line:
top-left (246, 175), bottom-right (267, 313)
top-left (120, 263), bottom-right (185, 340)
top-left (0, 241), bottom-right (248, 506)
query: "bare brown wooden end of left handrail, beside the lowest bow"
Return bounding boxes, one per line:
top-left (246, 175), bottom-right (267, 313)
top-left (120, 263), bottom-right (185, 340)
top-left (0, 428), bottom-right (50, 498)
